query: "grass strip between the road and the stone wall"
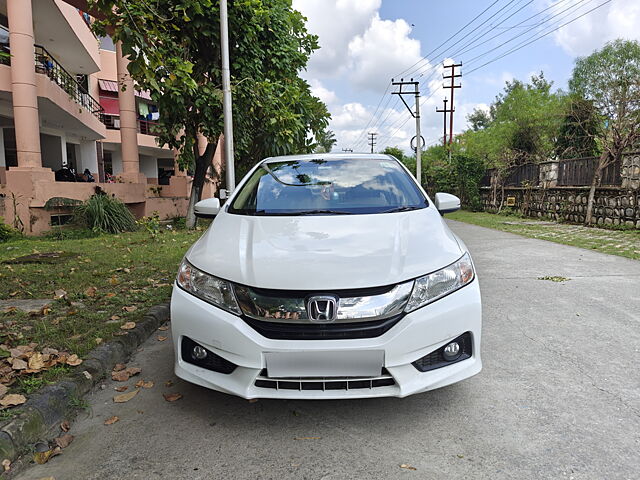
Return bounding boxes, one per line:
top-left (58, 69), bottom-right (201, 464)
top-left (446, 210), bottom-right (640, 260)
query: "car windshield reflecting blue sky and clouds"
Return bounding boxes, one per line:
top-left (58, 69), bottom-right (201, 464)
top-left (228, 158), bottom-right (427, 215)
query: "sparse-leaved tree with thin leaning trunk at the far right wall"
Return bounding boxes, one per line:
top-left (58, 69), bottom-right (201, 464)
top-left (569, 40), bottom-right (640, 224)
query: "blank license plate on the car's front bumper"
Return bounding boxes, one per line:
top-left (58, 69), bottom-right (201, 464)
top-left (264, 350), bottom-right (384, 378)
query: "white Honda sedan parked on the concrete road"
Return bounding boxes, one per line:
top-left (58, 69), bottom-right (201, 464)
top-left (171, 154), bottom-right (482, 399)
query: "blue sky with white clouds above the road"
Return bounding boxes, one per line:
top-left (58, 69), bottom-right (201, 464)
top-left (293, 0), bottom-right (640, 152)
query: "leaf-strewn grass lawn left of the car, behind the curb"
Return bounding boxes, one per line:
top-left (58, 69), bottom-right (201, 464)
top-left (0, 230), bottom-right (202, 394)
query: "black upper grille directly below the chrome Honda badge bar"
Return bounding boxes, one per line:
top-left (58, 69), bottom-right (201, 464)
top-left (242, 315), bottom-right (404, 340)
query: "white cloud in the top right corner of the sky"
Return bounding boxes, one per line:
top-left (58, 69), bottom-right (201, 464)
top-left (551, 0), bottom-right (640, 56)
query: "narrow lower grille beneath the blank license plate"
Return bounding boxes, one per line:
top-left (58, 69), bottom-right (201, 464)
top-left (255, 368), bottom-right (396, 392)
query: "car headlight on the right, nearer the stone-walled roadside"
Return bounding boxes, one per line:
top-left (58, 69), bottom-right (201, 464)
top-left (405, 253), bottom-right (474, 312)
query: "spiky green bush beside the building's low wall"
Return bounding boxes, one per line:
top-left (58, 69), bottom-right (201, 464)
top-left (74, 194), bottom-right (136, 233)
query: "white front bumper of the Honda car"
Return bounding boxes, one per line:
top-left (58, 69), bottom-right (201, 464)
top-left (171, 279), bottom-right (482, 399)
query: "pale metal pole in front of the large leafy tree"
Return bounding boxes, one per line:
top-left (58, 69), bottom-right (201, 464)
top-left (220, 0), bottom-right (236, 195)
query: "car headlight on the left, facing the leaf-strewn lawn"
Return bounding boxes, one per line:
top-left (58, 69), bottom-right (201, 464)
top-left (176, 260), bottom-right (241, 315)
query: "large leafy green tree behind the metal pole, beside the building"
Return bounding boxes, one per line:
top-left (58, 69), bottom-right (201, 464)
top-left (90, 0), bottom-right (329, 226)
